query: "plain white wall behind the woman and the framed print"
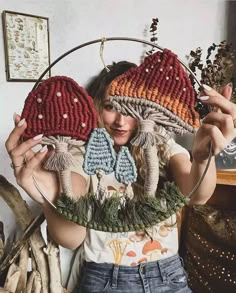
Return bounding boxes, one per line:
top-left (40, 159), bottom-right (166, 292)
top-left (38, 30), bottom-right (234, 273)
top-left (0, 0), bottom-right (227, 286)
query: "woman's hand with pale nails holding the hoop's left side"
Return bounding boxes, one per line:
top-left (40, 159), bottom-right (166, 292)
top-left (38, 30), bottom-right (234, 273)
top-left (5, 115), bottom-right (59, 204)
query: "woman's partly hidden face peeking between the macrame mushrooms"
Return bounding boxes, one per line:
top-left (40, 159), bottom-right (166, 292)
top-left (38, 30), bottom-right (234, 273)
top-left (101, 98), bottom-right (138, 147)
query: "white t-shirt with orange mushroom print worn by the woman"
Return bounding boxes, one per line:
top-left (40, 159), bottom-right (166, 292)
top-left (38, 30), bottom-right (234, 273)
top-left (72, 139), bottom-right (189, 266)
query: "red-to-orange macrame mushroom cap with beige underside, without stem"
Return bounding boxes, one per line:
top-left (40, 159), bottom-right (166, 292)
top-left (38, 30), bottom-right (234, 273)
top-left (109, 49), bottom-right (199, 134)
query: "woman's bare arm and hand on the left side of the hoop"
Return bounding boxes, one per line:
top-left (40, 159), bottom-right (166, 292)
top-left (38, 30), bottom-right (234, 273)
top-left (6, 115), bottom-right (86, 249)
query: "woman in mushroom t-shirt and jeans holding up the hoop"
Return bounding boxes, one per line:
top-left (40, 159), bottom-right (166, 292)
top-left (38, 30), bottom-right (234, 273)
top-left (6, 62), bottom-right (236, 293)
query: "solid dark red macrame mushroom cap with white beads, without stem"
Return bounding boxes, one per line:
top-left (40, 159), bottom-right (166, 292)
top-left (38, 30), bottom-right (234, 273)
top-left (21, 76), bottom-right (98, 141)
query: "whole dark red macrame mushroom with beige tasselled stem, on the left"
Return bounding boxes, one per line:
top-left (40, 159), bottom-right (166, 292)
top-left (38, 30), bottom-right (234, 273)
top-left (21, 76), bottom-right (98, 197)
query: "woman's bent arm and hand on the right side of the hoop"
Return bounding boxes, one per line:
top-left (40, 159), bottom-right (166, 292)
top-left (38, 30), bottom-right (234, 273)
top-left (170, 85), bottom-right (236, 204)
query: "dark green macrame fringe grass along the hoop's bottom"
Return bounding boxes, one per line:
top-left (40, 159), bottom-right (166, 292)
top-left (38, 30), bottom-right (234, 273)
top-left (56, 182), bottom-right (188, 232)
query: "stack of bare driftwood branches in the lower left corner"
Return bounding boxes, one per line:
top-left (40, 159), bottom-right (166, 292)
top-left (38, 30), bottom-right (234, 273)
top-left (0, 175), bottom-right (66, 293)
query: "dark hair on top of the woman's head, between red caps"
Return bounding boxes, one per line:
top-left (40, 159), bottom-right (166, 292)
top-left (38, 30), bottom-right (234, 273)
top-left (85, 61), bottom-right (137, 111)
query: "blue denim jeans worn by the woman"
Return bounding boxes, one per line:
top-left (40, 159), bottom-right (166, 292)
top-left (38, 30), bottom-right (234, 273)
top-left (79, 255), bottom-right (192, 293)
